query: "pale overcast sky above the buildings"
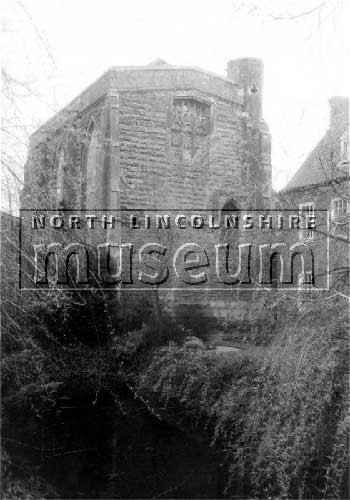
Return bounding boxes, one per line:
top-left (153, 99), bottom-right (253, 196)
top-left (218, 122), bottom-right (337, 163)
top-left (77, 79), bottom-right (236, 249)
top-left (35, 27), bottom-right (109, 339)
top-left (2, 0), bottom-right (349, 198)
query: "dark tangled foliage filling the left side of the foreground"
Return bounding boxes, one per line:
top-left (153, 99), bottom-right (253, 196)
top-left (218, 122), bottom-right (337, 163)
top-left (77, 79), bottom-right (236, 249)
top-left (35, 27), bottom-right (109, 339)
top-left (1, 290), bottom-right (182, 498)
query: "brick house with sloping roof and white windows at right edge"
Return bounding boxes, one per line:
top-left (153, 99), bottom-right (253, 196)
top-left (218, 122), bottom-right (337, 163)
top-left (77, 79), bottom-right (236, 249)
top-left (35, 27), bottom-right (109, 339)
top-left (279, 97), bottom-right (350, 287)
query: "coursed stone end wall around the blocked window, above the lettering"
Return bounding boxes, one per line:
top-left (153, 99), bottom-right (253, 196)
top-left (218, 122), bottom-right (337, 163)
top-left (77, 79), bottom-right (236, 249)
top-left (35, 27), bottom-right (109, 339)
top-left (119, 86), bottom-right (270, 210)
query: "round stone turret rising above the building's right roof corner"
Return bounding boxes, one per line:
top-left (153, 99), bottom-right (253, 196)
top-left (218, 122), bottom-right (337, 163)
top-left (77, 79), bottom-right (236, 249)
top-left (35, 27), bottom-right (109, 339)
top-left (227, 57), bottom-right (264, 122)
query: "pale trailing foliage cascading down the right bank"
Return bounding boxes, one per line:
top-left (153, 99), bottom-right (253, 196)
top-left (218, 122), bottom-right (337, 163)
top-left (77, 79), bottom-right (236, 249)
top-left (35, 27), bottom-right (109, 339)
top-left (139, 294), bottom-right (349, 498)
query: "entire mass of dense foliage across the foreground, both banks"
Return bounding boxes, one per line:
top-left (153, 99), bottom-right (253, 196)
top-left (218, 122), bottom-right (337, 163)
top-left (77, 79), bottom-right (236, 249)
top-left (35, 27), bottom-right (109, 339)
top-left (2, 284), bottom-right (349, 499)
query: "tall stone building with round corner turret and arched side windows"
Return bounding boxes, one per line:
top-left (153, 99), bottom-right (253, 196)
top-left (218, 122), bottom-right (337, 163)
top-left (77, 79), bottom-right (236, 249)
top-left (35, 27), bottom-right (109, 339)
top-left (21, 58), bottom-right (271, 322)
